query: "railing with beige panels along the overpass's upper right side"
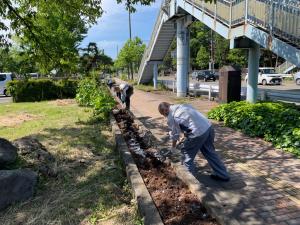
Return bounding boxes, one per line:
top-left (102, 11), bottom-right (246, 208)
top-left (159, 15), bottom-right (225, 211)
top-left (185, 0), bottom-right (300, 47)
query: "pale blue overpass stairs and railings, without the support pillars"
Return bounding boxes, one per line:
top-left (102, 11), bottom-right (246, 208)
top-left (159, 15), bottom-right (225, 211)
top-left (138, 0), bottom-right (300, 83)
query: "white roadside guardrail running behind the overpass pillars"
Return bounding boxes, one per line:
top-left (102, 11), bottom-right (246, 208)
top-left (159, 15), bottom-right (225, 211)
top-left (158, 80), bottom-right (300, 104)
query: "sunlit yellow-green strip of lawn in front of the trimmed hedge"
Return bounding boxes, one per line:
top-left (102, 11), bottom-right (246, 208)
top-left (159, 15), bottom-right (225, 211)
top-left (0, 102), bottom-right (90, 140)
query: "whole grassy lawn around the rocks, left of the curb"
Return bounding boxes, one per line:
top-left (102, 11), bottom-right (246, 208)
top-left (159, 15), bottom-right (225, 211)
top-left (0, 100), bottom-right (142, 225)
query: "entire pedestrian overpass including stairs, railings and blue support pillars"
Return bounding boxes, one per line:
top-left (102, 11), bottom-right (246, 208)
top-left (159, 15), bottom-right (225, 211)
top-left (138, 0), bottom-right (300, 102)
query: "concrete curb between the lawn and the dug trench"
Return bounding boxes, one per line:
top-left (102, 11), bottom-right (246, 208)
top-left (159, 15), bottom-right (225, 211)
top-left (110, 116), bottom-right (164, 225)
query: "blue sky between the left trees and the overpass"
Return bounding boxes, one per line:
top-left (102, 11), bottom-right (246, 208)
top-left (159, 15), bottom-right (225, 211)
top-left (81, 0), bottom-right (161, 59)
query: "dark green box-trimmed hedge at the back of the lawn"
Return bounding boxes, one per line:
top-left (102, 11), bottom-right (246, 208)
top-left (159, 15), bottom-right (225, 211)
top-left (7, 79), bottom-right (78, 102)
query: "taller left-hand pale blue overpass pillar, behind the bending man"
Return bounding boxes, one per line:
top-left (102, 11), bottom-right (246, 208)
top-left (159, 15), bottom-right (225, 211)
top-left (176, 17), bottom-right (190, 97)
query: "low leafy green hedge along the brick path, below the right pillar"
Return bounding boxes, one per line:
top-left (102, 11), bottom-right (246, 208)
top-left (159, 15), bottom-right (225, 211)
top-left (208, 102), bottom-right (300, 157)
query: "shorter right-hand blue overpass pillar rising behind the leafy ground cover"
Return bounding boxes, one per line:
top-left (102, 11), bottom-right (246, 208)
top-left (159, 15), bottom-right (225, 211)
top-left (247, 42), bottom-right (260, 103)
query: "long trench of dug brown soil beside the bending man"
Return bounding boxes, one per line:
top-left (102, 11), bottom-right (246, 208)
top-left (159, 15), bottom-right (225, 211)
top-left (113, 109), bottom-right (217, 225)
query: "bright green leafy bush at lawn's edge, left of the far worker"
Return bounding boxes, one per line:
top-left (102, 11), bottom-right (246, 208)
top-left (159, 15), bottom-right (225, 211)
top-left (76, 78), bottom-right (116, 119)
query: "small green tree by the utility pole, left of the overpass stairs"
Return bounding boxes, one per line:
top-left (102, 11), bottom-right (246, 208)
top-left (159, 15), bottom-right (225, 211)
top-left (115, 37), bottom-right (146, 80)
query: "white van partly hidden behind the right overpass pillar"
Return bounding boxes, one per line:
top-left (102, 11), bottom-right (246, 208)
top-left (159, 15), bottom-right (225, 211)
top-left (245, 67), bottom-right (282, 85)
